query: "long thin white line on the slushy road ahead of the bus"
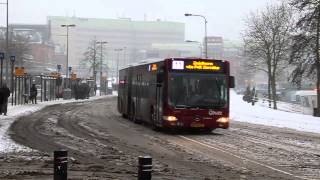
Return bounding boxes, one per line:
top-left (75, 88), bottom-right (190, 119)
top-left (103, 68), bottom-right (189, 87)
top-left (179, 136), bottom-right (312, 180)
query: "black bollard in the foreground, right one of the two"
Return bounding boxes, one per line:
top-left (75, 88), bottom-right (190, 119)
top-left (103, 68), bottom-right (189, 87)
top-left (138, 156), bottom-right (152, 180)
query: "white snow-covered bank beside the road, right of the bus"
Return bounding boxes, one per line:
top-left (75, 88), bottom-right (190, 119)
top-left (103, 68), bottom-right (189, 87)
top-left (230, 91), bottom-right (320, 133)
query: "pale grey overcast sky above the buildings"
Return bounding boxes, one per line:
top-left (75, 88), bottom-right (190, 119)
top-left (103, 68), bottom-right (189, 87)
top-left (0, 0), bottom-right (277, 41)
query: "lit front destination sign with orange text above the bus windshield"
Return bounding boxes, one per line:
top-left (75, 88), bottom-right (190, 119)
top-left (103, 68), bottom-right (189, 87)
top-left (172, 60), bottom-right (223, 72)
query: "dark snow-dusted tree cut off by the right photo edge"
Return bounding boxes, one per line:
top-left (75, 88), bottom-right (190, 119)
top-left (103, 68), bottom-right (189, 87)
top-left (289, 0), bottom-right (320, 116)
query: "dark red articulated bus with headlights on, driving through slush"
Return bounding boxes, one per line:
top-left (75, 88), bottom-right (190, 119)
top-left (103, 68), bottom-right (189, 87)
top-left (118, 58), bottom-right (234, 131)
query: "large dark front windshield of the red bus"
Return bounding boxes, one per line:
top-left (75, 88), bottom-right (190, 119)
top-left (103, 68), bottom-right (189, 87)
top-left (168, 73), bottom-right (228, 108)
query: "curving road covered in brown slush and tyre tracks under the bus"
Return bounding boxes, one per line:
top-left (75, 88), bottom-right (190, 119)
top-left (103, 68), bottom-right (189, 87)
top-left (5, 97), bottom-right (320, 180)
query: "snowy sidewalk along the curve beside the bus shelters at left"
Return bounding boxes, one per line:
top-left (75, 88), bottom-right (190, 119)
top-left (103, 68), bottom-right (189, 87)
top-left (0, 96), bottom-right (110, 152)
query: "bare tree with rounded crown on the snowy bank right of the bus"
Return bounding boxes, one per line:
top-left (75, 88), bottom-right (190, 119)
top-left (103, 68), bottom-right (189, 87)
top-left (243, 3), bottom-right (293, 109)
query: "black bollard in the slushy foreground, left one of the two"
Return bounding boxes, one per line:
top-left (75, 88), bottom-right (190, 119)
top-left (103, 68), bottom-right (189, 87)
top-left (53, 150), bottom-right (68, 180)
